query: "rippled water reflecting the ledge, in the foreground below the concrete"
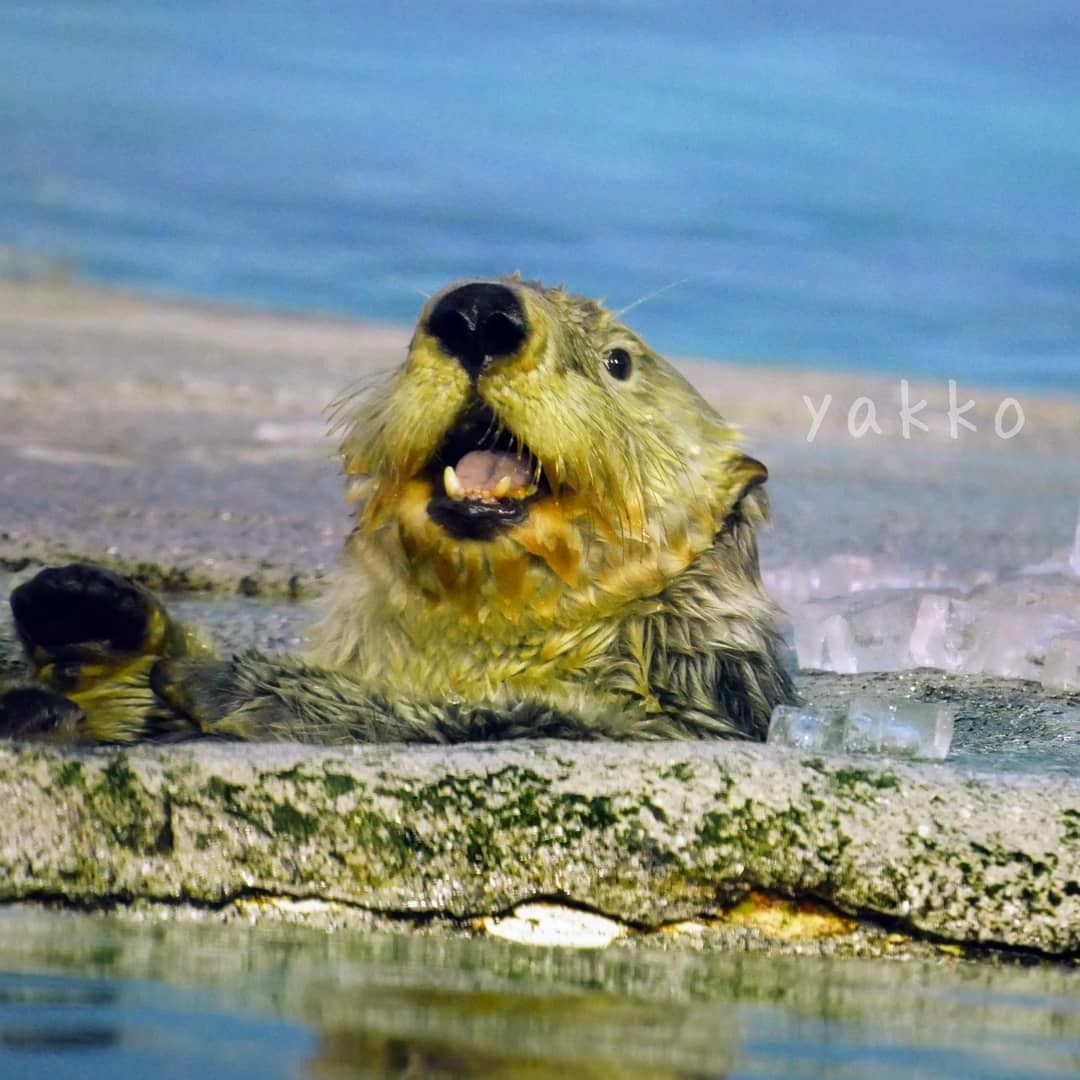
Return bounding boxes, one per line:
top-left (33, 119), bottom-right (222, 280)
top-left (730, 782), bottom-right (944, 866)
top-left (0, 912), bottom-right (1080, 1078)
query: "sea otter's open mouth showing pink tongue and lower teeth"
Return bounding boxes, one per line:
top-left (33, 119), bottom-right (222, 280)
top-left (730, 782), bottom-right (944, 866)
top-left (427, 405), bottom-right (548, 540)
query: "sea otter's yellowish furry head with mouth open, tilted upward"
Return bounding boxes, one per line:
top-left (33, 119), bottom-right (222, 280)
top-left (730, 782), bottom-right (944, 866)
top-left (339, 276), bottom-right (766, 625)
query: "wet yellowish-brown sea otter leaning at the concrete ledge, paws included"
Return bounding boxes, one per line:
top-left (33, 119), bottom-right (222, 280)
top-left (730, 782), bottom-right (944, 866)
top-left (0, 275), bottom-right (794, 743)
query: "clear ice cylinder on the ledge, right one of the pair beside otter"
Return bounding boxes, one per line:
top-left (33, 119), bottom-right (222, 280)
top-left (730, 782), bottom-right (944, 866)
top-left (843, 697), bottom-right (953, 761)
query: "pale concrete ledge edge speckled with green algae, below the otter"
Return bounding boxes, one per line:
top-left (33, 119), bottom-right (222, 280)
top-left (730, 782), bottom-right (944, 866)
top-left (0, 742), bottom-right (1080, 956)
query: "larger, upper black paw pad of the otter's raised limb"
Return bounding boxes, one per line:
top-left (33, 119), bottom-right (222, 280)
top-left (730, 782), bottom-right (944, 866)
top-left (11, 563), bottom-right (168, 666)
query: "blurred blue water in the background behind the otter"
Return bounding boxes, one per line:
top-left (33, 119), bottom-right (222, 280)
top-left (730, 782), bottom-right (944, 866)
top-left (0, 0), bottom-right (1080, 390)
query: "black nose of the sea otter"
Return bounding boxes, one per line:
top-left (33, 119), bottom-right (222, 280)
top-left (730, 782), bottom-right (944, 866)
top-left (428, 282), bottom-right (528, 379)
